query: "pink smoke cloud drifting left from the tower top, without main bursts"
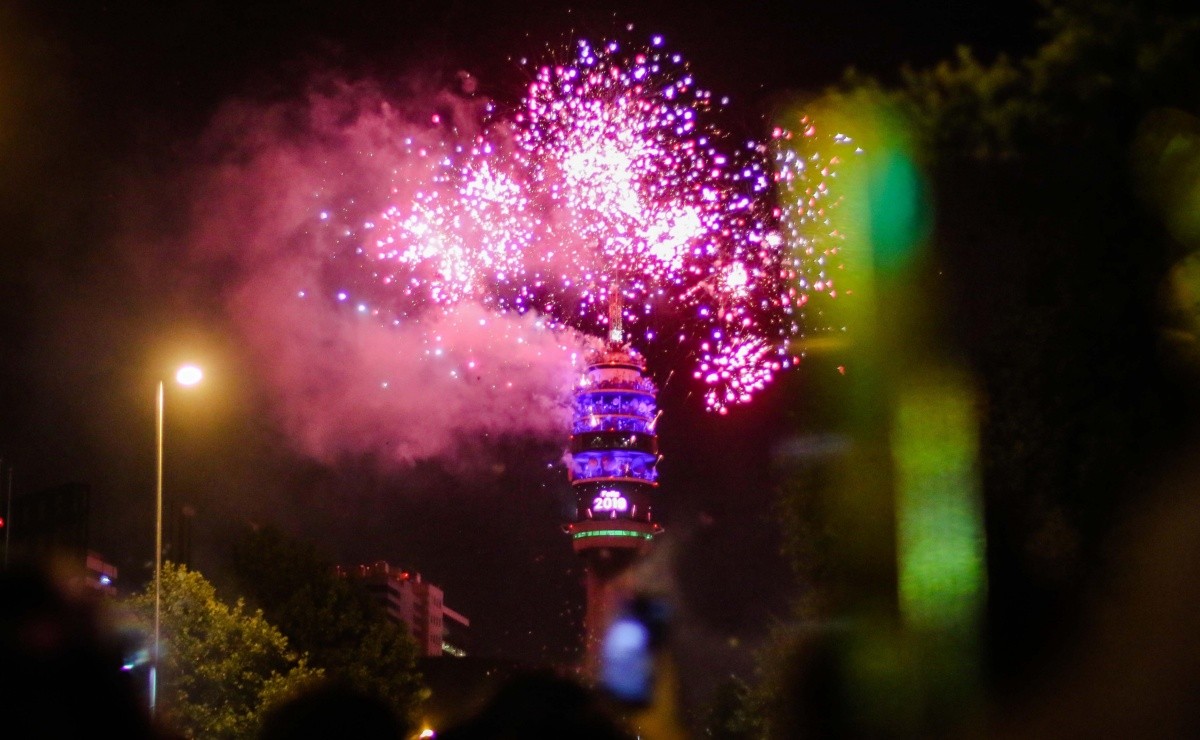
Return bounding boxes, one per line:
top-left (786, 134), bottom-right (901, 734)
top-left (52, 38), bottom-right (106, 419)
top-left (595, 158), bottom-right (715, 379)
top-left (186, 76), bottom-right (587, 463)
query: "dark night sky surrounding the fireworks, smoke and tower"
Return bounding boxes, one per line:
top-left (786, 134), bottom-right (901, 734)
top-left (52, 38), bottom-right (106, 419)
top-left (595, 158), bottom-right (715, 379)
top-left (0, 0), bottom-right (1034, 695)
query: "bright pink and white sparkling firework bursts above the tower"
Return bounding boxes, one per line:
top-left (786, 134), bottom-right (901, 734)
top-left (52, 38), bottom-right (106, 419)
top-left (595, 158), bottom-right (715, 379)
top-left (324, 37), bottom-right (833, 413)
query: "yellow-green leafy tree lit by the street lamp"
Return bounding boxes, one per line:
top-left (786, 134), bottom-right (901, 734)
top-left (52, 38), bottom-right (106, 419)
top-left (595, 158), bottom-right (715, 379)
top-left (126, 562), bottom-right (323, 738)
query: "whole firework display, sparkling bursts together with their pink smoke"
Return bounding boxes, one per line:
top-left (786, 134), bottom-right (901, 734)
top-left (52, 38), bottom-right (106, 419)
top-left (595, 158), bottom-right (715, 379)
top-left (169, 33), bottom-right (833, 461)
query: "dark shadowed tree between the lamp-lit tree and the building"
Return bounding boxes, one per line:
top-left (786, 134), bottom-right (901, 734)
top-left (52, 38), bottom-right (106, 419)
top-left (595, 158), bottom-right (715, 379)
top-left (233, 527), bottom-right (427, 721)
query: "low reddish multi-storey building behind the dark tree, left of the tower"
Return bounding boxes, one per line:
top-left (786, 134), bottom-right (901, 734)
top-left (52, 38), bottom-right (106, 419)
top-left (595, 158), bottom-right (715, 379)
top-left (337, 561), bottom-right (470, 657)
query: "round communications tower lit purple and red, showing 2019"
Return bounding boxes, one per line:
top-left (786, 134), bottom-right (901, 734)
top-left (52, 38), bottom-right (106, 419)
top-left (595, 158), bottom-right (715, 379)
top-left (563, 299), bottom-right (662, 673)
